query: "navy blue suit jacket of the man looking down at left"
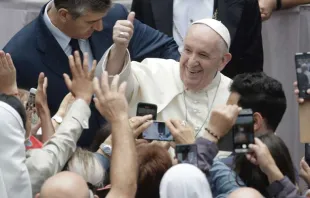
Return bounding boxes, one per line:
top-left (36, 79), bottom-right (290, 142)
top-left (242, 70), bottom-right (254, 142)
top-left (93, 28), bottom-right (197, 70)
top-left (3, 4), bottom-right (180, 146)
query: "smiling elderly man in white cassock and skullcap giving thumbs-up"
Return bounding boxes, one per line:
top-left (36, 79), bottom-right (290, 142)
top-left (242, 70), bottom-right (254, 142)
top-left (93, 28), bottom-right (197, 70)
top-left (96, 13), bottom-right (231, 137)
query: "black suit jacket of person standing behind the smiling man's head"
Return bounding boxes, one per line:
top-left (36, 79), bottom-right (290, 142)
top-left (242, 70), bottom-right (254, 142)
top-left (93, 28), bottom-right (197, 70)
top-left (131, 0), bottom-right (263, 78)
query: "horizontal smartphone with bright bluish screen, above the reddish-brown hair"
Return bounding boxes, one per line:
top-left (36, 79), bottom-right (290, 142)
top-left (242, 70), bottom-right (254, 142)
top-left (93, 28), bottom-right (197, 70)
top-left (142, 121), bottom-right (173, 141)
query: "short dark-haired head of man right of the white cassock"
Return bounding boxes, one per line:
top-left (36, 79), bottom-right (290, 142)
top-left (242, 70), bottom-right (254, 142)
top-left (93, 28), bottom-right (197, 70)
top-left (227, 72), bottom-right (286, 132)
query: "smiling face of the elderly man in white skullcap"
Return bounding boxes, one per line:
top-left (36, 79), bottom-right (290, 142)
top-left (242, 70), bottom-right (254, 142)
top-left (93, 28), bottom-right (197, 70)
top-left (180, 24), bottom-right (231, 91)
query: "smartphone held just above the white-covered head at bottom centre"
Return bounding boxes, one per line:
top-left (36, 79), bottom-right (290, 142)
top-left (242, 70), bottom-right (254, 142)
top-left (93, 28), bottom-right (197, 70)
top-left (175, 144), bottom-right (198, 166)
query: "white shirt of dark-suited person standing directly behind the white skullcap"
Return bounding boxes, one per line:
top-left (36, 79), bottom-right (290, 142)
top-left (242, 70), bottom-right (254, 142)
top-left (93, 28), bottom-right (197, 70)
top-left (173, 0), bottom-right (214, 52)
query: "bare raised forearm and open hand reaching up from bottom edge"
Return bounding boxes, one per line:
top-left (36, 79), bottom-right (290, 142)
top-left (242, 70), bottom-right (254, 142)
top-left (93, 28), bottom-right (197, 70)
top-left (93, 72), bottom-right (137, 198)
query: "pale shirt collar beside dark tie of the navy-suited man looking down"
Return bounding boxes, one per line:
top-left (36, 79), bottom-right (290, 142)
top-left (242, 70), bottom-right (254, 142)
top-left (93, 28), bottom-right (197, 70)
top-left (44, 1), bottom-right (94, 69)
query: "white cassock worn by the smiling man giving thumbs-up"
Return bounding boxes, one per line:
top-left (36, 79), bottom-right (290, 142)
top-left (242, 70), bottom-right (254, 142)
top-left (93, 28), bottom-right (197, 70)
top-left (96, 45), bottom-right (232, 137)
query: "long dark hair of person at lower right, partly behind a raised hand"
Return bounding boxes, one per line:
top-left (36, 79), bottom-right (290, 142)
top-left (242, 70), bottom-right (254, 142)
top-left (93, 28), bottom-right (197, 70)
top-left (235, 133), bottom-right (296, 197)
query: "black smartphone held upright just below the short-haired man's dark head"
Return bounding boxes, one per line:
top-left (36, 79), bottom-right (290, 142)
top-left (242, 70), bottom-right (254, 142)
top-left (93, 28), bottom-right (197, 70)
top-left (232, 109), bottom-right (254, 153)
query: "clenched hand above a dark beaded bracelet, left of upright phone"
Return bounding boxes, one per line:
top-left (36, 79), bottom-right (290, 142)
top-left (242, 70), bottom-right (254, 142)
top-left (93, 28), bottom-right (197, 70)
top-left (204, 105), bottom-right (241, 138)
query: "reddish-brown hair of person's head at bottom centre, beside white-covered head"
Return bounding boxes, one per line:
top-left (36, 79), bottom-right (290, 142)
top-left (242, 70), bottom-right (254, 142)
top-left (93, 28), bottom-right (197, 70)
top-left (136, 144), bottom-right (172, 198)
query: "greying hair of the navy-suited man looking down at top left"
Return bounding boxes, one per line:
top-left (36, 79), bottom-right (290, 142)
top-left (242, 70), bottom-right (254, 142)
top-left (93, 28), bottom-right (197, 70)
top-left (54, 0), bottom-right (111, 19)
